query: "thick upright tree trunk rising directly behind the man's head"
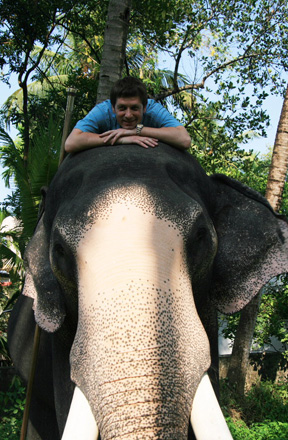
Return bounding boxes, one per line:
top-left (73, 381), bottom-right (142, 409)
top-left (97, 0), bottom-right (132, 104)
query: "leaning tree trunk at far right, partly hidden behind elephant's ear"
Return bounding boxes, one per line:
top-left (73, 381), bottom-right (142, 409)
top-left (227, 83), bottom-right (288, 395)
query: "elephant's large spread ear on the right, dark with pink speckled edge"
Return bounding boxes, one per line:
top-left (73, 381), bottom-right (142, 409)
top-left (211, 175), bottom-right (288, 314)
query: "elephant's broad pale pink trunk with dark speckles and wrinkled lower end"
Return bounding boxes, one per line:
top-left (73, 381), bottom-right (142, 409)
top-left (70, 199), bottom-right (210, 440)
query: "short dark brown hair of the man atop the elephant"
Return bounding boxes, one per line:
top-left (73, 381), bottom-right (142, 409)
top-left (110, 76), bottom-right (148, 107)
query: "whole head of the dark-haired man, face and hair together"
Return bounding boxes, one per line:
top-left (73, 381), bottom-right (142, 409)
top-left (110, 76), bottom-right (147, 130)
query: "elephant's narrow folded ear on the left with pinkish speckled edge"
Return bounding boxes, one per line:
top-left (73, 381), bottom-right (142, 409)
top-left (23, 214), bottom-right (65, 332)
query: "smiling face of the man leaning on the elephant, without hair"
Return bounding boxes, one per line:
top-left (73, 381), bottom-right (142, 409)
top-left (113, 96), bottom-right (146, 130)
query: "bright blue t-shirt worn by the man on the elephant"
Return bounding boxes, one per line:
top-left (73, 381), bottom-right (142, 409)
top-left (74, 99), bottom-right (181, 134)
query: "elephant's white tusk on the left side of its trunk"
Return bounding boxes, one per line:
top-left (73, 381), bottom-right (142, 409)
top-left (61, 387), bottom-right (99, 440)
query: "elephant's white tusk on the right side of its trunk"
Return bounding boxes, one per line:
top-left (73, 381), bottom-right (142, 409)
top-left (191, 373), bottom-right (233, 440)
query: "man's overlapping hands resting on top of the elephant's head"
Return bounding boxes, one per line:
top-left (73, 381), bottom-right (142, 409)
top-left (99, 128), bottom-right (158, 148)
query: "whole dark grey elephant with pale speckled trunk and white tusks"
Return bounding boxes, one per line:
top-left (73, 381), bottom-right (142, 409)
top-left (8, 143), bottom-right (288, 440)
